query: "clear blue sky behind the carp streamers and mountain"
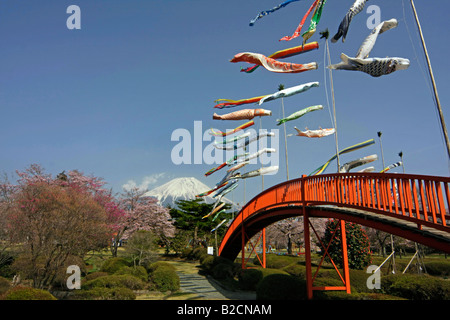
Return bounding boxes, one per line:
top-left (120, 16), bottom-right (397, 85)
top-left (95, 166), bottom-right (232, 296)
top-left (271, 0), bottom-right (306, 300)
top-left (0, 0), bottom-right (450, 206)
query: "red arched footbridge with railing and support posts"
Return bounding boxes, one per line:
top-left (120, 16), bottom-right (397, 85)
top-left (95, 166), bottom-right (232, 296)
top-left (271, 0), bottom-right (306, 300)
top-left (219, 173), bottom-right (450, 297)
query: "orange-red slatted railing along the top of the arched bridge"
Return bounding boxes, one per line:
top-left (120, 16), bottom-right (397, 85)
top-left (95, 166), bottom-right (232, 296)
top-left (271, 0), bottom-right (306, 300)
top-left (230, 173), bottom-right (450, 231)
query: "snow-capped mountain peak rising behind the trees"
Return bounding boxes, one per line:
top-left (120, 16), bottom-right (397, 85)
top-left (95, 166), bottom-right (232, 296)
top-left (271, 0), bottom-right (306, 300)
top-left (145, 177), bottom-right (237, 210)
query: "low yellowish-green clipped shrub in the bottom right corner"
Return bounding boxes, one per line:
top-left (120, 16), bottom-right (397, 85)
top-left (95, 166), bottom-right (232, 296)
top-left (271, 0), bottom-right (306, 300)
top-left (381, 274), bottom-right (450, 300)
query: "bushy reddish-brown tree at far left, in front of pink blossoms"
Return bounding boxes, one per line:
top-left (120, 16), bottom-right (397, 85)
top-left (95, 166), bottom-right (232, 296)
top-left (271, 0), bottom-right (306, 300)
top-left (3, 165), bottom-right (123, 288)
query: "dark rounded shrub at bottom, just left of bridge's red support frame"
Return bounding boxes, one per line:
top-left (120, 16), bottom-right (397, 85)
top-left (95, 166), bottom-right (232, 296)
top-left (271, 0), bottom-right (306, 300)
top-left (256, 274), bottom-right (307, 300)
